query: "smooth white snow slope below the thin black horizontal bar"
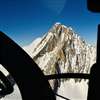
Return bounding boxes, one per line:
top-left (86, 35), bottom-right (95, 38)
top-left (57, 79), bottom-right (88, 100)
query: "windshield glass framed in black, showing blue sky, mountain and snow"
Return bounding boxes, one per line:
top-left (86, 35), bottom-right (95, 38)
top-left (0, 0), bottom-right (100, 100)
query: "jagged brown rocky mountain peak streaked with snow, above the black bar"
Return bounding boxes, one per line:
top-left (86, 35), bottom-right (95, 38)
top-left (24, 23), bottom-right (96, 91)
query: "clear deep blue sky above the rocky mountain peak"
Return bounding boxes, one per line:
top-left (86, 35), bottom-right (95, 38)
top-left (0, 0), bottom-right (100, 46)
